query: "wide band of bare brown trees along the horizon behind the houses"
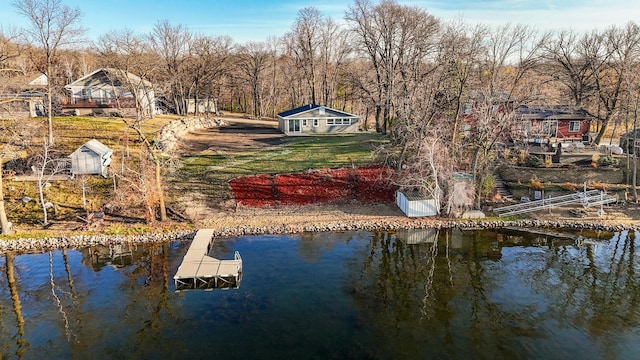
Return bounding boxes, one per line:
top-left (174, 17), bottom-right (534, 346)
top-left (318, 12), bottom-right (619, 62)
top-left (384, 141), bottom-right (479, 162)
top-left (0, 0), bottom-right (640, 132)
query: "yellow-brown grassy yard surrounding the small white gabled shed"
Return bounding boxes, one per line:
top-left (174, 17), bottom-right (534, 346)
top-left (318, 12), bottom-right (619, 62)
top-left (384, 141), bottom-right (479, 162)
top-left (0, 116), bottom-right (175, 232)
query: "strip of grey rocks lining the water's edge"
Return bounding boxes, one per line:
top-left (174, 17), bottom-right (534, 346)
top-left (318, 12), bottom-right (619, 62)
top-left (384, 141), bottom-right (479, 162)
top-left (0, 219), bottom-right (640, 253)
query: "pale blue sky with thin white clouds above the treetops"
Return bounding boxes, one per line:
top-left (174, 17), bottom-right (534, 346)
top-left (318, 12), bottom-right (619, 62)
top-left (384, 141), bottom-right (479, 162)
top-left (0, 0), bottom-right (640, 43)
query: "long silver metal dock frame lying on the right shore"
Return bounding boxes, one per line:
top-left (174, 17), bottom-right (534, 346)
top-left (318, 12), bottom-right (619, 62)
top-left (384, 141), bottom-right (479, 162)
top-left (493, 190), bottom-right (618, 217)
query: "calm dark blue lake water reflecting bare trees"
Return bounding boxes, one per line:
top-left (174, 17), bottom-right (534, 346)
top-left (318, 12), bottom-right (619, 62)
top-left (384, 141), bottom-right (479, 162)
top-left (0, 230), bottom-right (640, 359)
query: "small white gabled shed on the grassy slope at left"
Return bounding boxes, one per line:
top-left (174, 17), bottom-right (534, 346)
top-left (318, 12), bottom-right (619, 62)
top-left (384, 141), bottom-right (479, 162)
top-left (69, 139), bottom-right (113, 177)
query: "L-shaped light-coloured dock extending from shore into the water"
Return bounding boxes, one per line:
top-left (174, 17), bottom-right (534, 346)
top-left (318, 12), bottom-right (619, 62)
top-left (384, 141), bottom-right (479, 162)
top-left (173, 229), bottom-right (242, 291)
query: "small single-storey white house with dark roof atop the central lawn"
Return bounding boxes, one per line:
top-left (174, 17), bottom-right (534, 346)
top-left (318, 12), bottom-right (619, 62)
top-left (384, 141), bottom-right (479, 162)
top-left (278, 104), bottom-right (360, 135)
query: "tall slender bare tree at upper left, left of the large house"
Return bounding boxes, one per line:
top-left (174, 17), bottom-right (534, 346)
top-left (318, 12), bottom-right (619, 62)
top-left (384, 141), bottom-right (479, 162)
top-left (13, 0), bottom-right (84, 145)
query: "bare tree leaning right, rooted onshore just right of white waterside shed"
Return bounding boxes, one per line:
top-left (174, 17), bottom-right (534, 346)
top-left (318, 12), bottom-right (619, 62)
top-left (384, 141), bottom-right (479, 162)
top-left (468, 25), bottom-right (545, 207)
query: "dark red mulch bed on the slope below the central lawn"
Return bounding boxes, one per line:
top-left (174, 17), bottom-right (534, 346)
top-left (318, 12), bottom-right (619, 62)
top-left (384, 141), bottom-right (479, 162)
top-left (229, 165), bottom-right (397, 207)
